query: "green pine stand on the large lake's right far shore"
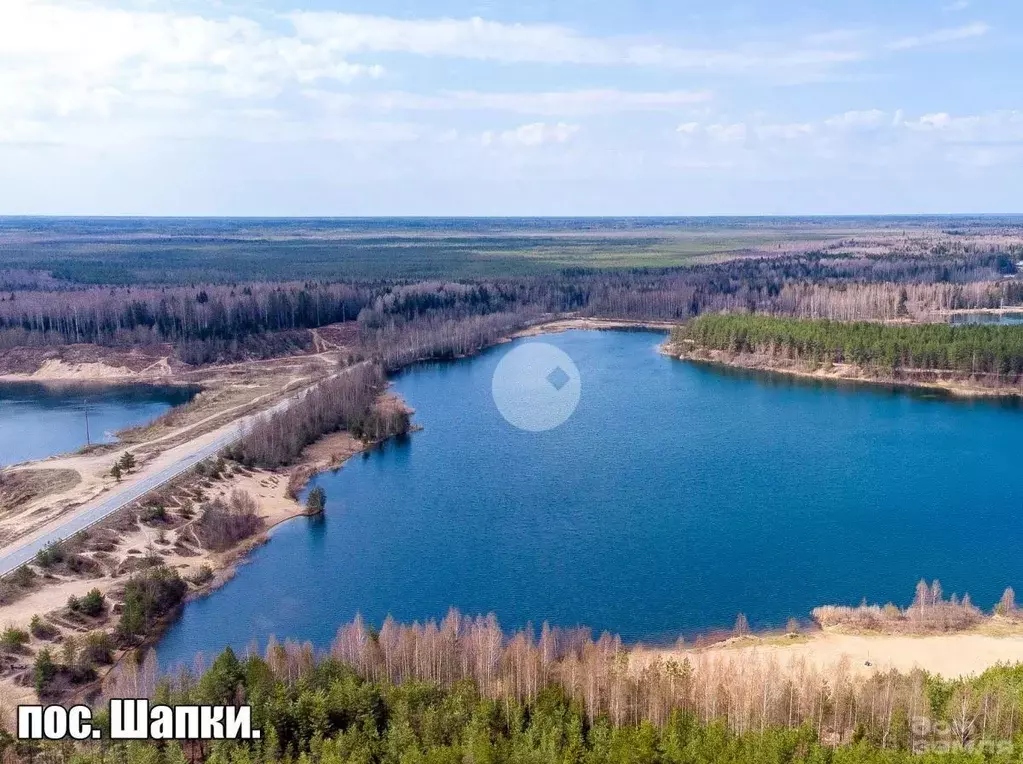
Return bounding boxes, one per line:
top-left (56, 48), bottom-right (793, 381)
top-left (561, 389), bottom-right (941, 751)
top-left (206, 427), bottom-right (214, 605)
top-left (672, 315), bottom-right (1023, 380)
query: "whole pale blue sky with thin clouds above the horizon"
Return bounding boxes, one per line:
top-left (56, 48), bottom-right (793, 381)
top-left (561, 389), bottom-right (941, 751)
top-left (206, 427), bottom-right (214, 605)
top-left (0, 0), bottom-right (1023, 216)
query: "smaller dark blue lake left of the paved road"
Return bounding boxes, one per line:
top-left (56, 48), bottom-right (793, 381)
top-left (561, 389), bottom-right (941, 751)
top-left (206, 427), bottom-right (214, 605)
top-left (0, 383), bottom-right (196, 466)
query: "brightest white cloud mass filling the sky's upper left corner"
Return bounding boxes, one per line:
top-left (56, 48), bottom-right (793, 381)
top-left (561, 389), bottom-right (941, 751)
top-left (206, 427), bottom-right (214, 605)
top-left (0, 0), bottom-right (382, 131)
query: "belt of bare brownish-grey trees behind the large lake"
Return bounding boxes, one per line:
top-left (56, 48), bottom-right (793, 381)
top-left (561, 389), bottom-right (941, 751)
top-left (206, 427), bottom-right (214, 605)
top-left (0, 252), bottom-right (1023, 367)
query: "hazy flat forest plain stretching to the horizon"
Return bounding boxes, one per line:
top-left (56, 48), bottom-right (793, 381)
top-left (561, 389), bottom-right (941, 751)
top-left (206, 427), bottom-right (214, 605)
top-left (7, 216), bottom-right (1023, 288)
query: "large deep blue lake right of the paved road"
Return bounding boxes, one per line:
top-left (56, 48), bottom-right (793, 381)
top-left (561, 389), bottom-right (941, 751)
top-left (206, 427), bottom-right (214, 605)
top-left (159, 331), bottom-right (1023, 665)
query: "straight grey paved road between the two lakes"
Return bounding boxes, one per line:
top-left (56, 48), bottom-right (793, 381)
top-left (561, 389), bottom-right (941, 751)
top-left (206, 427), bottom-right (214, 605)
top-left (0, 390), bottom-right (308, 576)
